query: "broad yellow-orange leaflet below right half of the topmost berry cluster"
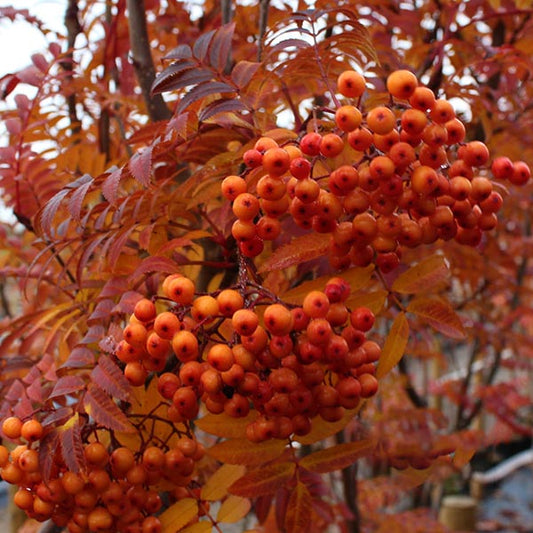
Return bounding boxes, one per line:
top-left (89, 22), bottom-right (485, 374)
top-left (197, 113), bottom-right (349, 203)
top-left (392, 255), bottom-right (450, 294)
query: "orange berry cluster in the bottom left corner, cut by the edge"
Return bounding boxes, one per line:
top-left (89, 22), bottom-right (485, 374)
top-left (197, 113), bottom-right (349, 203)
top-left (0, 416), bottom-right (204, 533)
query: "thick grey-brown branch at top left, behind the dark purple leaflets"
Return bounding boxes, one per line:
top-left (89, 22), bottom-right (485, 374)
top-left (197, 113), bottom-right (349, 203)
top-left (126, 0), bottom-right (171, 121)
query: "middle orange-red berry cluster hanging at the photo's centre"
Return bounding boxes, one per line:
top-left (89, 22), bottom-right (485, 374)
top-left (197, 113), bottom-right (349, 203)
top-left (116, 274), bottom-right (381, 441)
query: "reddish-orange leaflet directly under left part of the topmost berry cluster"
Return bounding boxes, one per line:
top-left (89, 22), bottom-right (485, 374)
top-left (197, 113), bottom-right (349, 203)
top-left (259, 233), bottom-right (330, 272)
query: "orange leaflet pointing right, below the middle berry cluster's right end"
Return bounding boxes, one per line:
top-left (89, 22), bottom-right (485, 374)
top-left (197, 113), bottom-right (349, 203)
top-left (300, 439), bottom-right (375, 474)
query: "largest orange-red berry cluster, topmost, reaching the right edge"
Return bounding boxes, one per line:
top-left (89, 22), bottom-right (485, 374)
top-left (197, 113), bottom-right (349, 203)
top-left (222, 70), bottom-right (530, 271)
